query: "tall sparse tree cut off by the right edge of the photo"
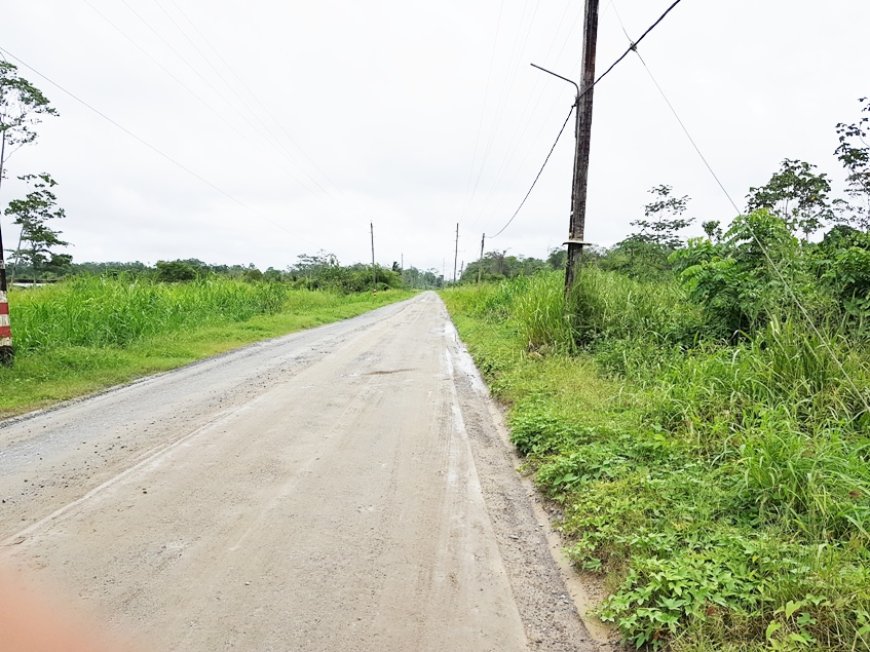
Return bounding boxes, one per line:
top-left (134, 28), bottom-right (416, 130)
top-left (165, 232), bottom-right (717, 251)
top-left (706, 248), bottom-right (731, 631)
top-left (834, 97), bottom-right (870, 231)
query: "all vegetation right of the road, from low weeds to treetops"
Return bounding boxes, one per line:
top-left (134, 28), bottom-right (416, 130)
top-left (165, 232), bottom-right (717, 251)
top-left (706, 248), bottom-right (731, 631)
top-left (443, 98), bottom-right (870, 652)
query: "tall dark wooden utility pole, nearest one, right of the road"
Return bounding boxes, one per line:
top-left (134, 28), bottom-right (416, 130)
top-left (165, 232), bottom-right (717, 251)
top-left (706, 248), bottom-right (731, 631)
top-left (565, 0), bottom-right (598, 291)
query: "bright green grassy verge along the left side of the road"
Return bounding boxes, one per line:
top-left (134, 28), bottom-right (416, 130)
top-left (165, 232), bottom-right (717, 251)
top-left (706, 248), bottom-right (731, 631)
top-left (0, 278), bottom-right (411, 417)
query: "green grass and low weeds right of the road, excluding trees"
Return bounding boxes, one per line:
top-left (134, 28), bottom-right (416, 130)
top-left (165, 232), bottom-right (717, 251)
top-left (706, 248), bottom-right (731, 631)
top-left (443, 269), bottom-right (870, 652)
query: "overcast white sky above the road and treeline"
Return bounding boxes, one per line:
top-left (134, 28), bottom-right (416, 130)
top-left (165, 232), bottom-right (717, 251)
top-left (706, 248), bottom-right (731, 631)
top-left (0, 0), bottom-right (870, 276)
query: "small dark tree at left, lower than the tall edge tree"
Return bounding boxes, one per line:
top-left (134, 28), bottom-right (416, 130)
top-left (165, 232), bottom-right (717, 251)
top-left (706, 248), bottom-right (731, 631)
top-left (5, 172), bottom-right (69, 280)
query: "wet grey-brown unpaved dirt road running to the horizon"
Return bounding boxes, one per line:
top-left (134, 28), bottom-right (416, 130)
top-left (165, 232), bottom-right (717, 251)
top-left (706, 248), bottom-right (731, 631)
top-left (0, 293), bottom-right (596, 652)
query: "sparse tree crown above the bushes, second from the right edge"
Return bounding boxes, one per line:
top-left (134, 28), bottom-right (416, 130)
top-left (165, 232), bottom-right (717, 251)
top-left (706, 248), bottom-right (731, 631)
top-left (746, 158), bottom-right (834, 241)
